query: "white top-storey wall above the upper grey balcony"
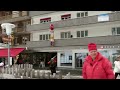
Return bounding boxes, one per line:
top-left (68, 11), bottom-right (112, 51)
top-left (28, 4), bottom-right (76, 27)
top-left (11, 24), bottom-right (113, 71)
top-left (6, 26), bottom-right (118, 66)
top-left (31, 11), bottom-right (111, 25)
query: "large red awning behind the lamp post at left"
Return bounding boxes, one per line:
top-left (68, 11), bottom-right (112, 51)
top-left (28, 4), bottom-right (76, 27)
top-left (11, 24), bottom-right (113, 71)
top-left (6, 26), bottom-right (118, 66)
top-left (0, 48), bottom-right (25, 57)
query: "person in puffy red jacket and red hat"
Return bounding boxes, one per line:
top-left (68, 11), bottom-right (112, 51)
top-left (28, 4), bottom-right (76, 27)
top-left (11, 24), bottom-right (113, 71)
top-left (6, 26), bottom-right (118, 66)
top-left (82, 43), bottom-right (115, 79)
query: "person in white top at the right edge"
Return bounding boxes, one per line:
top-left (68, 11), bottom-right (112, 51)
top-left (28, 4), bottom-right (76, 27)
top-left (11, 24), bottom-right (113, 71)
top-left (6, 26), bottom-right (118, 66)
top-left (114, 56), bottom-right (120, 79)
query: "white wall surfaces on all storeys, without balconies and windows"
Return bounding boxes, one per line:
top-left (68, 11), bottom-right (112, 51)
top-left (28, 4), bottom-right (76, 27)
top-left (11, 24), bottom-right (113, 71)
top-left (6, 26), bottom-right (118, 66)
top-left (28, 11), bottom-right (120, 68)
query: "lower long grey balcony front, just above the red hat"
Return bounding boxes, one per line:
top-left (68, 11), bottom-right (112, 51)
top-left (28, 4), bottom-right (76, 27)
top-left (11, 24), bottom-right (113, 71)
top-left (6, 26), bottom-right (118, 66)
top-left (26, 36), bottom-right (120, 48)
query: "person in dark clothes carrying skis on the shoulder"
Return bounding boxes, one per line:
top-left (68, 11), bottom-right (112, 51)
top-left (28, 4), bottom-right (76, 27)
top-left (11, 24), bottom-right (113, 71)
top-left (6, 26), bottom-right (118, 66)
top-left (48, 57), bottom-right (57, 75)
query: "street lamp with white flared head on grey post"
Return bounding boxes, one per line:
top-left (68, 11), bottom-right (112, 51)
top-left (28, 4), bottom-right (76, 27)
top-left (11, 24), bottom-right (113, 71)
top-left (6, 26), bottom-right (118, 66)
top-left (1, 23), bottom-right (15, 66)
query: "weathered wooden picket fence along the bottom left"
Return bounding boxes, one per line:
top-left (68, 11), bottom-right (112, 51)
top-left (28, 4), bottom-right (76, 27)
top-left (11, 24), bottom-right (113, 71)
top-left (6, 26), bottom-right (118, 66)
top-left (0, 64), bottom-right (63, 79)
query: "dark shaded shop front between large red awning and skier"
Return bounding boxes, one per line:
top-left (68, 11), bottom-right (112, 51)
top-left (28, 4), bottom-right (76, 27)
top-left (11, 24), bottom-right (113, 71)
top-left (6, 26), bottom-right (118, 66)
top-left (25, 52), bottom-right (57, 68)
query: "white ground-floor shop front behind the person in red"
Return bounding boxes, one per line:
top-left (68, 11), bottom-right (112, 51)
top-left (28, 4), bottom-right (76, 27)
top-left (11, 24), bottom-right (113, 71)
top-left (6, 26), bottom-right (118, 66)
top-left (57, 48), bottom-right (120, 68)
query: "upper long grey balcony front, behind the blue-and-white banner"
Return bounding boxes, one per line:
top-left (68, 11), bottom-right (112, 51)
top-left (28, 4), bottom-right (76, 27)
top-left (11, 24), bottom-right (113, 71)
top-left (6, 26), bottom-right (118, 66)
top-left (26, 12), bottom-right (120, 31)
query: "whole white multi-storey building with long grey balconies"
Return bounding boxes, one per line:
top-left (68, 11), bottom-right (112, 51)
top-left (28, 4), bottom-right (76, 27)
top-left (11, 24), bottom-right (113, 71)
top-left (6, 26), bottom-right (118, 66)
top-left (27, 11), bottom-right (120, 68)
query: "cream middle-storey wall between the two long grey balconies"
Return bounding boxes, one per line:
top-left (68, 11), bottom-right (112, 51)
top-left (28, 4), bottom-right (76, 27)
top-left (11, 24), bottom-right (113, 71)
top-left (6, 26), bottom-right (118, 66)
top-left (32, 22), bottom-right (120, 41)
